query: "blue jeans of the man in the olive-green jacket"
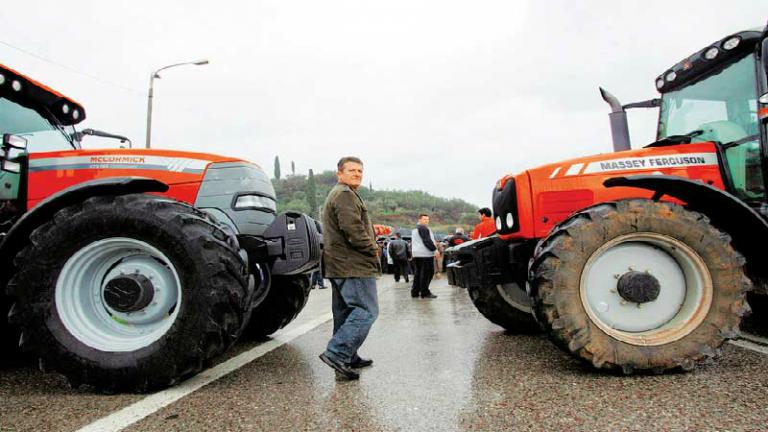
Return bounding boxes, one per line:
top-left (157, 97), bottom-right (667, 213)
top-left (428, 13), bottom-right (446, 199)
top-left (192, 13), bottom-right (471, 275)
top-left (325, 277), bottom-right (379, 363)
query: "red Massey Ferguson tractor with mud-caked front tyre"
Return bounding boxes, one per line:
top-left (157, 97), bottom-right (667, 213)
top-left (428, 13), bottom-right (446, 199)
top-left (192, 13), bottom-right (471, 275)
top-left (449, 24), bottom-right (768, 374)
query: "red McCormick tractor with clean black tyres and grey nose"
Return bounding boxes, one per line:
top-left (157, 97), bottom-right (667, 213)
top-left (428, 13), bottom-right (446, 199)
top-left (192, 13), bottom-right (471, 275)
top-left (0, 65), bottom-right (321, 391)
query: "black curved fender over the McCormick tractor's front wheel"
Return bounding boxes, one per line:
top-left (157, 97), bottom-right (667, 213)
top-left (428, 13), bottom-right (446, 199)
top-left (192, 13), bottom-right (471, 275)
top-left (0, 177), bottom-right (168, 285)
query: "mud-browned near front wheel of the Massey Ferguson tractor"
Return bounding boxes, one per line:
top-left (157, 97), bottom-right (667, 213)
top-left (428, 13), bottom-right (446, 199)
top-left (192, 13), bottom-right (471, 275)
top-left (530, 200), bottom-right (751, 374)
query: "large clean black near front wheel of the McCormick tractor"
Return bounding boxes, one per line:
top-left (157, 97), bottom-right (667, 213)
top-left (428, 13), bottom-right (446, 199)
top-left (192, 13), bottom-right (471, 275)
top-left (8, 194), bottom-right (248, 392)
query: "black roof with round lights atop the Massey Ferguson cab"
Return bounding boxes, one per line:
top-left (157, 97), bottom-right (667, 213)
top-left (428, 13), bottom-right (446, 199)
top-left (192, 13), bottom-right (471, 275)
top-left (656, 28), bottom-right (765, 93)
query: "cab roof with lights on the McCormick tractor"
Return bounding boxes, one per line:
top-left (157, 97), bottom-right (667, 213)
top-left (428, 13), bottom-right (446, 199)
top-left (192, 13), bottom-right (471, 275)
top-left (0, 63), bottom-right (85, 125)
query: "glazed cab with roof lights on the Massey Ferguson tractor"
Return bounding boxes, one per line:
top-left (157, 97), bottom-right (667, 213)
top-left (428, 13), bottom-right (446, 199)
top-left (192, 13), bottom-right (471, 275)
top-left (656, 30), bottom-right (766, 207)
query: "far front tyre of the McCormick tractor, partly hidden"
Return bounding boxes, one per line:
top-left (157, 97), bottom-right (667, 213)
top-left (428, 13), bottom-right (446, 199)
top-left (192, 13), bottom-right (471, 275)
top-left (245, 274), bottom-right (311, 339)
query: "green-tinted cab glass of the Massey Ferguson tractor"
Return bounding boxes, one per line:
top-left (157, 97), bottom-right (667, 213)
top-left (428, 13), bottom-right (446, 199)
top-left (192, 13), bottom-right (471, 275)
top-left (659, 55), bottom-right (765, 203)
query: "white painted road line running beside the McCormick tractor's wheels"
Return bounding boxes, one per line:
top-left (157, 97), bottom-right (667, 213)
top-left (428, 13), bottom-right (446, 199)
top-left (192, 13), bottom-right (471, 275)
top-left (78, 313), bottom-right (332, 432)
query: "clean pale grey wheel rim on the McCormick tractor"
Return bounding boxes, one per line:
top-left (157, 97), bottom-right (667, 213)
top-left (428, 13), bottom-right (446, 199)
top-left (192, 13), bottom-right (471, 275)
top-left (55, 237), bottom-right (181, 352)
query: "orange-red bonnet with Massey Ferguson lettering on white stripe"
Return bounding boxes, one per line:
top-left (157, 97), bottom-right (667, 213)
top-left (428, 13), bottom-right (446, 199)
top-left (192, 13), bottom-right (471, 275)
top-left (498, 142), bottom-right (725, 239)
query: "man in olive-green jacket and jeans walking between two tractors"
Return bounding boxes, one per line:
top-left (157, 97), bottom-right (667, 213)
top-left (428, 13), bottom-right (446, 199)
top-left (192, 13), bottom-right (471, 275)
top-left (320, 156), bottom-right (380, 380)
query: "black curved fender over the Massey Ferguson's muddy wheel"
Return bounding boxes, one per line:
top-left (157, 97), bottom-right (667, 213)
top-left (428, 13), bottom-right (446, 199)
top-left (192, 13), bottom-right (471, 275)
top-left (603, 175), bottom-right (768, 277)
